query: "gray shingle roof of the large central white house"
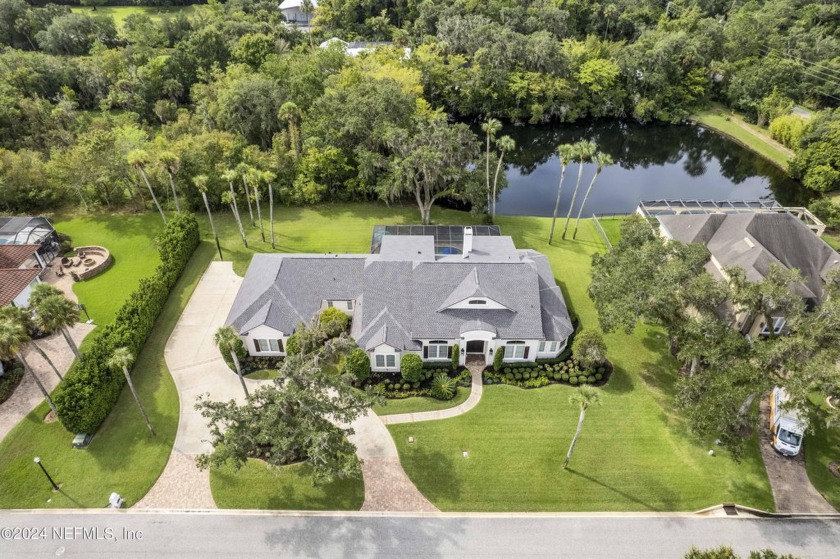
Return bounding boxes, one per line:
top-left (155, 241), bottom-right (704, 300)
top-left (227, 231), bottom-right (572, 349)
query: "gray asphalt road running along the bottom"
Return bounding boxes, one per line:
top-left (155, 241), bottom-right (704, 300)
top-left (0, 511), bottom-right (840, 559)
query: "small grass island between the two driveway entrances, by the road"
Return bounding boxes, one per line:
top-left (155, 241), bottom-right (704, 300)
top-left (210, 460), bottom-right (365, 510)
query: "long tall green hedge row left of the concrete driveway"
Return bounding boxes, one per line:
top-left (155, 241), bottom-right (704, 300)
top-left (54, 213), bottom-right (200, 433)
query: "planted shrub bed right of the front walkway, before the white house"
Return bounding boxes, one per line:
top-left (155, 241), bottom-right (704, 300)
top-left (484, 357), bottom-right (612, 388)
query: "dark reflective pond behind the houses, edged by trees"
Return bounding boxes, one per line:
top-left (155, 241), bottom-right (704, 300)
top-left (496, 120), bottom-right (807, 216)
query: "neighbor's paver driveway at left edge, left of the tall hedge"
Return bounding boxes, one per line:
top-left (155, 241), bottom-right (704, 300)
top-left (0, 323), bottom-right (94, 440)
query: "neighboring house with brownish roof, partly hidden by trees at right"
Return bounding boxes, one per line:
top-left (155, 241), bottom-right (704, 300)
top-left (656, 212), bottom-right (840, 338)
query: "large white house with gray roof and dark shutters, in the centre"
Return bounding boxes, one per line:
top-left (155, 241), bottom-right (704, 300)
top-left (226, 226), bottom-right (573, 372)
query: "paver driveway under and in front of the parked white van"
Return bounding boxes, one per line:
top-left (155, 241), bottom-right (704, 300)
top-left (758, 396), bottom-right (837, 513)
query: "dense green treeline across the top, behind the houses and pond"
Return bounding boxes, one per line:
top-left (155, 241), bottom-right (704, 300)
top-left (0, 0), bottom-right (840, 218)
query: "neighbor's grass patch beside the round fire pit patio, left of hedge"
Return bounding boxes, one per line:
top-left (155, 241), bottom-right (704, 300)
top-left (53, 213), bottom-right (163, 324)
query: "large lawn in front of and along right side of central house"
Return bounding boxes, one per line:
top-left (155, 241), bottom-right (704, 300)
top-left (389, 217), bottom-right (774, 511)
